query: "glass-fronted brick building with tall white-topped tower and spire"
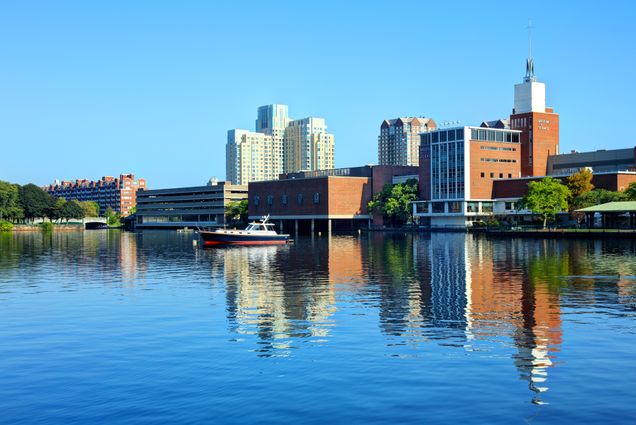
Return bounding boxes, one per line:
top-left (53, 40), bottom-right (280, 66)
top-left (414, 53), bottom-right (559, 228)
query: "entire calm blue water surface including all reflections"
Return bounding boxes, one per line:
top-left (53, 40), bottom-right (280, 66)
top-left (0, 231), bottom-right (636, 424)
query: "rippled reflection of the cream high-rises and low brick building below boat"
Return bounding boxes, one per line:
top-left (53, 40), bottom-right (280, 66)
top-left (222, 238), bottom-right (352, 356)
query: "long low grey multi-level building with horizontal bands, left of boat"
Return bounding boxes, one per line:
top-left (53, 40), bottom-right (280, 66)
top-left (136, 182), bottom-right (247, 229)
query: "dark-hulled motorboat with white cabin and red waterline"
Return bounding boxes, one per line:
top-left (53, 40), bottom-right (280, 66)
top-left (198, 215), bottom-right (289, 246)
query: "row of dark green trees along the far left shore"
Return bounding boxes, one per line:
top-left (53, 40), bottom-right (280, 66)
top-left (0, 180), bottom-right (99, 223)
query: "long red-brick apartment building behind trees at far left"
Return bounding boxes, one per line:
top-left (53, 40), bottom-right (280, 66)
top-left (44, 174), bottom-right (146, 217)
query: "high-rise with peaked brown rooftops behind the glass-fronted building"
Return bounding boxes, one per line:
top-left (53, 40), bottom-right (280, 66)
top-left (378, 117), bottom-right (436, 166)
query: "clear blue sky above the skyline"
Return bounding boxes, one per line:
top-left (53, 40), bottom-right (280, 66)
top-left (0, 0), bottom-right (636, 189)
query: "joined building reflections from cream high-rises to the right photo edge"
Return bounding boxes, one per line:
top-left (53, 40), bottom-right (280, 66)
top-left (216, 233), bottom-right (635, 404)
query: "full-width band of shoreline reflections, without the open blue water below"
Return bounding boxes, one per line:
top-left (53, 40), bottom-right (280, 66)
top-left (0, 231), bottom-right (636, 404)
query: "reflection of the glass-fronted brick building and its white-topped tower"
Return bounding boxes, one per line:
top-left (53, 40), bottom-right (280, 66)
top-left (380, 233), bottom-right (562, 403)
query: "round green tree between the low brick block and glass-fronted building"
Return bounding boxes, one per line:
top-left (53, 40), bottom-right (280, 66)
top-left (367, 179), bottom-right (417, 224)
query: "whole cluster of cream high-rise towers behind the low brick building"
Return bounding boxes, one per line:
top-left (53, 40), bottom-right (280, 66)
top-left (226, 104), bottom-right (335, 184)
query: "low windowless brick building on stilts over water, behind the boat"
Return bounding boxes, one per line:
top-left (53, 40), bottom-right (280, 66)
top-left (249, 165), bottom-right (417, 232)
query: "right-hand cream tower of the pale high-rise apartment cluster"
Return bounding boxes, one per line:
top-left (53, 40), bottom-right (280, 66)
top-left (283, 117), bottom-right (335, 173)
